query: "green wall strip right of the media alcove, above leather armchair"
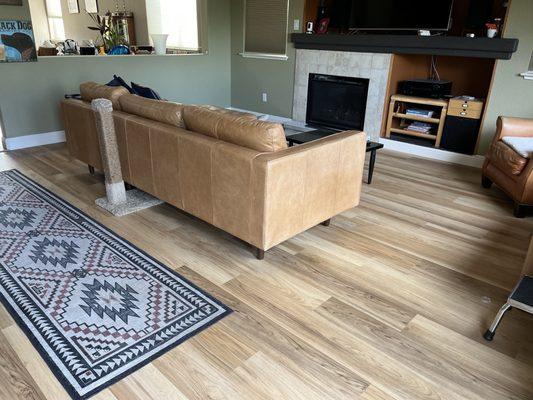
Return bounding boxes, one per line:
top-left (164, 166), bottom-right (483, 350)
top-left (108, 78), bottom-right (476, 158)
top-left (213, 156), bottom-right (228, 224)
top-left (478, 0), bottom-right (533, 154)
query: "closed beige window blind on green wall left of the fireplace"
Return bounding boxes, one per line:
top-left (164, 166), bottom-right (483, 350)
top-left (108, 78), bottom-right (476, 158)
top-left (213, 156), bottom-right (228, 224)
top-left (244, 0), bottom-right (289, 56)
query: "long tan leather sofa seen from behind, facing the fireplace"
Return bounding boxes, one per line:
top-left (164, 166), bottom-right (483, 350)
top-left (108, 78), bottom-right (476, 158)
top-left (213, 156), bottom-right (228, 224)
top-left (61, 81), bottom-right (366, 258)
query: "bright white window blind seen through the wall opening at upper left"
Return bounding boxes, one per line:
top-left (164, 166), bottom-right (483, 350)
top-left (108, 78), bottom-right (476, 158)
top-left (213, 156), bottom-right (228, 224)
top-left (146, 0), bottom-right (200, 50)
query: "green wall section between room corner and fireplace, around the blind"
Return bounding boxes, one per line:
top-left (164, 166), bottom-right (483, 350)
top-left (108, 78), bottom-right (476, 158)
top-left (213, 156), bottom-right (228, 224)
top-left (231, 0), bottom-right (304, 117)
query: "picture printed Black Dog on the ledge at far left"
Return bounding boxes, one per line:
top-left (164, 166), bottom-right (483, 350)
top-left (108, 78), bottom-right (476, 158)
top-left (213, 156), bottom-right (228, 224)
top-left (0, 20), bottom-right (37, 63)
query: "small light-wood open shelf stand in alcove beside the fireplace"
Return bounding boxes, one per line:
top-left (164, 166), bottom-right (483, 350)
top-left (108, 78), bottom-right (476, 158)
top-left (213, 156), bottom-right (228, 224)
top-left (385, 95), bottom-right (448, 148)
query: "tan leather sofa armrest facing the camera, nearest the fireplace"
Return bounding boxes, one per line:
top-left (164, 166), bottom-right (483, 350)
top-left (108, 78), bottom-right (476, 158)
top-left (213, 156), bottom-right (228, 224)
top-left (252, 131), bottom-right (366, 250)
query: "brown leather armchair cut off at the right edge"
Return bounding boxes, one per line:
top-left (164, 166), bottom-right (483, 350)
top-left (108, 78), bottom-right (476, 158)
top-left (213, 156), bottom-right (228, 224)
top-left (482, 117), bottom-right (533, 218)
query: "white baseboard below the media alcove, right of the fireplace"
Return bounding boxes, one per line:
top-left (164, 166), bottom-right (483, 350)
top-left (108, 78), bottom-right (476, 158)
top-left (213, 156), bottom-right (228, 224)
top-left (379, 138), bottom-right (485, 168)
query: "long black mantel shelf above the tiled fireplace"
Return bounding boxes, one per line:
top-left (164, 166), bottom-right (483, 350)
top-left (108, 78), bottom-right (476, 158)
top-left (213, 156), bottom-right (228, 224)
top-left (292, 33), bottom-right (518, 60)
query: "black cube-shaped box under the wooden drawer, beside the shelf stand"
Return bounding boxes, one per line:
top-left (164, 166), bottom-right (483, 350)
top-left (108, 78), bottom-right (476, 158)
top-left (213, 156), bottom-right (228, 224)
top-left (440, 115), bottom-right (481, 154)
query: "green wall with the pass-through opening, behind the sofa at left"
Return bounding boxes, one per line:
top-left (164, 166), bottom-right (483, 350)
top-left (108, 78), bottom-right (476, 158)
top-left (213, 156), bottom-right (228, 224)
top-left (0, 0), bottom-right (231, 138)
